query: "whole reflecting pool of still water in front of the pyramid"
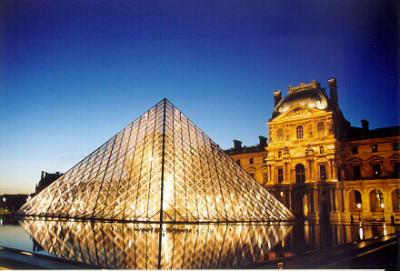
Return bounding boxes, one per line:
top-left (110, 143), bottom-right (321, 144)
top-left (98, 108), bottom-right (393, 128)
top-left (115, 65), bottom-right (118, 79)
top-left (0, 219), bottom-right (396, 269)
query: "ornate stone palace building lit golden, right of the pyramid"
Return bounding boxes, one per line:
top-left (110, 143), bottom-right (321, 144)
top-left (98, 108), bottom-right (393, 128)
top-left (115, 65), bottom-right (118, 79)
top-left (226, 79), bottom-right (400, 223)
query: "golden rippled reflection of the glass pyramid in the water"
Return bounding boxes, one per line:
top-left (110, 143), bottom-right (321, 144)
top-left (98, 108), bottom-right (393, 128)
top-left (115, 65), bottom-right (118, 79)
top-left (20, 219), bottom-right (292, 269)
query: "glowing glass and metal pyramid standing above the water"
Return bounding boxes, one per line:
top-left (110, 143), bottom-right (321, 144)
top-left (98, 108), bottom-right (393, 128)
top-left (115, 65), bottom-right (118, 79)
top-left (20, 99), bottom-right (292, 222)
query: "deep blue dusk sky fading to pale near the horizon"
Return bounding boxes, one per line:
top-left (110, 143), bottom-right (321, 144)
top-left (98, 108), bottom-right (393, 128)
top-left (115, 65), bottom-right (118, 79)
top-left (0, 0), bottom-right (400, 194)
